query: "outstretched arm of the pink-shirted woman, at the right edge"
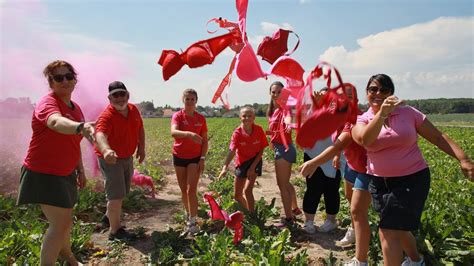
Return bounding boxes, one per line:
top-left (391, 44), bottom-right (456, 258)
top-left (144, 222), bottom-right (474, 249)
top-left (417, 119), bottom-right (474, 179)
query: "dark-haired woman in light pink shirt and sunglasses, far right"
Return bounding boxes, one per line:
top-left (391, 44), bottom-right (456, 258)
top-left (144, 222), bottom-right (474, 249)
top-left (352, 74), bottom-right (474, 266)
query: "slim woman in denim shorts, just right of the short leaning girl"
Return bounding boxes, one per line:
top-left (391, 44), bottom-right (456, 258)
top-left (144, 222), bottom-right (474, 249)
top-left (267, 81), bottom-right (302, 227)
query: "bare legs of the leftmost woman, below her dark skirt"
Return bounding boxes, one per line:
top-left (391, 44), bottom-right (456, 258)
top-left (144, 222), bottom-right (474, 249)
top-left (40, 204), bottom-right (77, 265)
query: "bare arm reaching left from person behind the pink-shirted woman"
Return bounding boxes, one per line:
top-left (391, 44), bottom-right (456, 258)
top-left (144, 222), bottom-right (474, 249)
top-left (300, 132), bottom-right (352, 176)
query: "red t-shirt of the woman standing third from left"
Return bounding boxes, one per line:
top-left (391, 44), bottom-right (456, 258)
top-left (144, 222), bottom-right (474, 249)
top-left (171, 109), bottom-right (207, 159)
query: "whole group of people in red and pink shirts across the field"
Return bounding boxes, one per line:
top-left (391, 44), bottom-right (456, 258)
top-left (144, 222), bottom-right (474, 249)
top-left (17, 60), bottom-right (474, 265)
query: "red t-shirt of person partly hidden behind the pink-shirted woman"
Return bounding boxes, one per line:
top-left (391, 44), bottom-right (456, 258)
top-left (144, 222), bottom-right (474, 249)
top-left (342, 123), bottom-right (367, 174)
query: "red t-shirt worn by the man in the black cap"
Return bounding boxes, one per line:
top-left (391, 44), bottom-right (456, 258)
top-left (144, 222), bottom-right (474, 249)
top-left (95, 103), bottom-right (143, 158)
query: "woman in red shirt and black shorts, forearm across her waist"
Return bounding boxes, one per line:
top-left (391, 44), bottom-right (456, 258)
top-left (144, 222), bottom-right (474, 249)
top-left (171, 89), bottom-right (208, 234)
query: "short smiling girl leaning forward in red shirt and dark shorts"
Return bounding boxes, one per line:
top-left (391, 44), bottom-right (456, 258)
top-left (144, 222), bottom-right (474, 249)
top-left (219, 107), bottom-right (268, 212)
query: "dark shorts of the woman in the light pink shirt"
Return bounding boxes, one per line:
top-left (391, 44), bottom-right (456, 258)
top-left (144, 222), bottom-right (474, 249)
top-left (369, 168), bottom-right (430, 231)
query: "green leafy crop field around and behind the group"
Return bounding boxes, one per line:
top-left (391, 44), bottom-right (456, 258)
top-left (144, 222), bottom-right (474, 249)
top-left (0, 115), bottom-right (474, 265)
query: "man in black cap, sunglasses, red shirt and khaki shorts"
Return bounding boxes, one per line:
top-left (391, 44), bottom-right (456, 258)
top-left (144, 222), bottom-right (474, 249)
top-left (95, 81), bottom-right (145, 240)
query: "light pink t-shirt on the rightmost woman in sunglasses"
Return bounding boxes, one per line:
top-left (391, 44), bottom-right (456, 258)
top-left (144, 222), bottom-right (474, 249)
top-left (357, 106), bottom-right (428, 177)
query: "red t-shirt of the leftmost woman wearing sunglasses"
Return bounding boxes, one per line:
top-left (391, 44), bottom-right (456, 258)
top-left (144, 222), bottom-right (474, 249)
top-left (23, 92), bottom-right (84, 176)
